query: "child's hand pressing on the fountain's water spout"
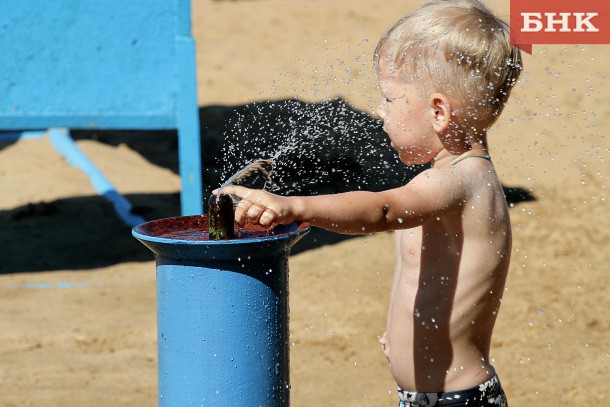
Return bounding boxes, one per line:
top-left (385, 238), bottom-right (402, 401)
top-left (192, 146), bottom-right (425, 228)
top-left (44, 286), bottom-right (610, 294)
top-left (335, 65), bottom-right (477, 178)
top-left (214, 185), bottom-right (297, 228)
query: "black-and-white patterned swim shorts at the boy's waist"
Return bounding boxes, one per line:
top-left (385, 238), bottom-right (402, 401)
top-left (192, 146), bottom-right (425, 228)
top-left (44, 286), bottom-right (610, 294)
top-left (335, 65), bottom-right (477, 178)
top-left (398, 370), bottom-right (508, 407)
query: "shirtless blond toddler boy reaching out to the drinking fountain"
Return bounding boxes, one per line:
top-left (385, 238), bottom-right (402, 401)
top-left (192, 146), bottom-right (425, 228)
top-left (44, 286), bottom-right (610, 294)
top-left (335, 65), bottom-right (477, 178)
top-left (217, 0), bottom-right (522, 407)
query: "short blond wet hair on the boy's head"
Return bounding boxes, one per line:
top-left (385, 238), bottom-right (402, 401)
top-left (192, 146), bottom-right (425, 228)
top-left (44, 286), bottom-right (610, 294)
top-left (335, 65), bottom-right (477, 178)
top-left (375, 0), bottom-right (522, 128)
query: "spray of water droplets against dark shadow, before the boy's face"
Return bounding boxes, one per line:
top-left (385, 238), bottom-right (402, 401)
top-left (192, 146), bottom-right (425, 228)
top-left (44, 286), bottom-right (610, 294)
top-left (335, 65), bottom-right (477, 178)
top-left (213, 99), bottom-right (421, 201)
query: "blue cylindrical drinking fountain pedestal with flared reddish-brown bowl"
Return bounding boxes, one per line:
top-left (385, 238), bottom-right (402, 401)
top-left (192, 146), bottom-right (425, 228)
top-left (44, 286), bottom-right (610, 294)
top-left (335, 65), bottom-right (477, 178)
top-left (133, 216), bottom-right (309, 407)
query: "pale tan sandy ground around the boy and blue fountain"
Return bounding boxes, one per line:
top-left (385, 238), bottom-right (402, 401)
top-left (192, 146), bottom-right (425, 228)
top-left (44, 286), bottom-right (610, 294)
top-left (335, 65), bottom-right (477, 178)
top-left (0, 0), bottom-right (610, 407)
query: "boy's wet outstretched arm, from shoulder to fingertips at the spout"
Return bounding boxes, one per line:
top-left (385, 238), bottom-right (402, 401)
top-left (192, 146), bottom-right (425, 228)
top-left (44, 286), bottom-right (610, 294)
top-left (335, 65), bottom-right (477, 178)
top-left (223, 169), bottom-right (463, 234)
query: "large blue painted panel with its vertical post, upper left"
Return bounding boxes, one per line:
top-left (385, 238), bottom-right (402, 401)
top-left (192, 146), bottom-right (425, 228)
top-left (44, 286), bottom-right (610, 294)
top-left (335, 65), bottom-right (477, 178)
top-left (0, 0), bottom-right (203, 215)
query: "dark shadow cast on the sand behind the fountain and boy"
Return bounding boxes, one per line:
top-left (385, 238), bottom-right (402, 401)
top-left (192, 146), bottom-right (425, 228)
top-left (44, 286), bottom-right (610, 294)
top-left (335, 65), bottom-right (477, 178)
top-left (0, 99), bottom-right (535, 274)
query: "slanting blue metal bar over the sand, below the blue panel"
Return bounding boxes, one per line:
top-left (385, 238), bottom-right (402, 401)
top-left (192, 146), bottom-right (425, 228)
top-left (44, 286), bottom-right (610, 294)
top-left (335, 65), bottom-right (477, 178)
top-left (49, 128), bottom-right (145, 227)
